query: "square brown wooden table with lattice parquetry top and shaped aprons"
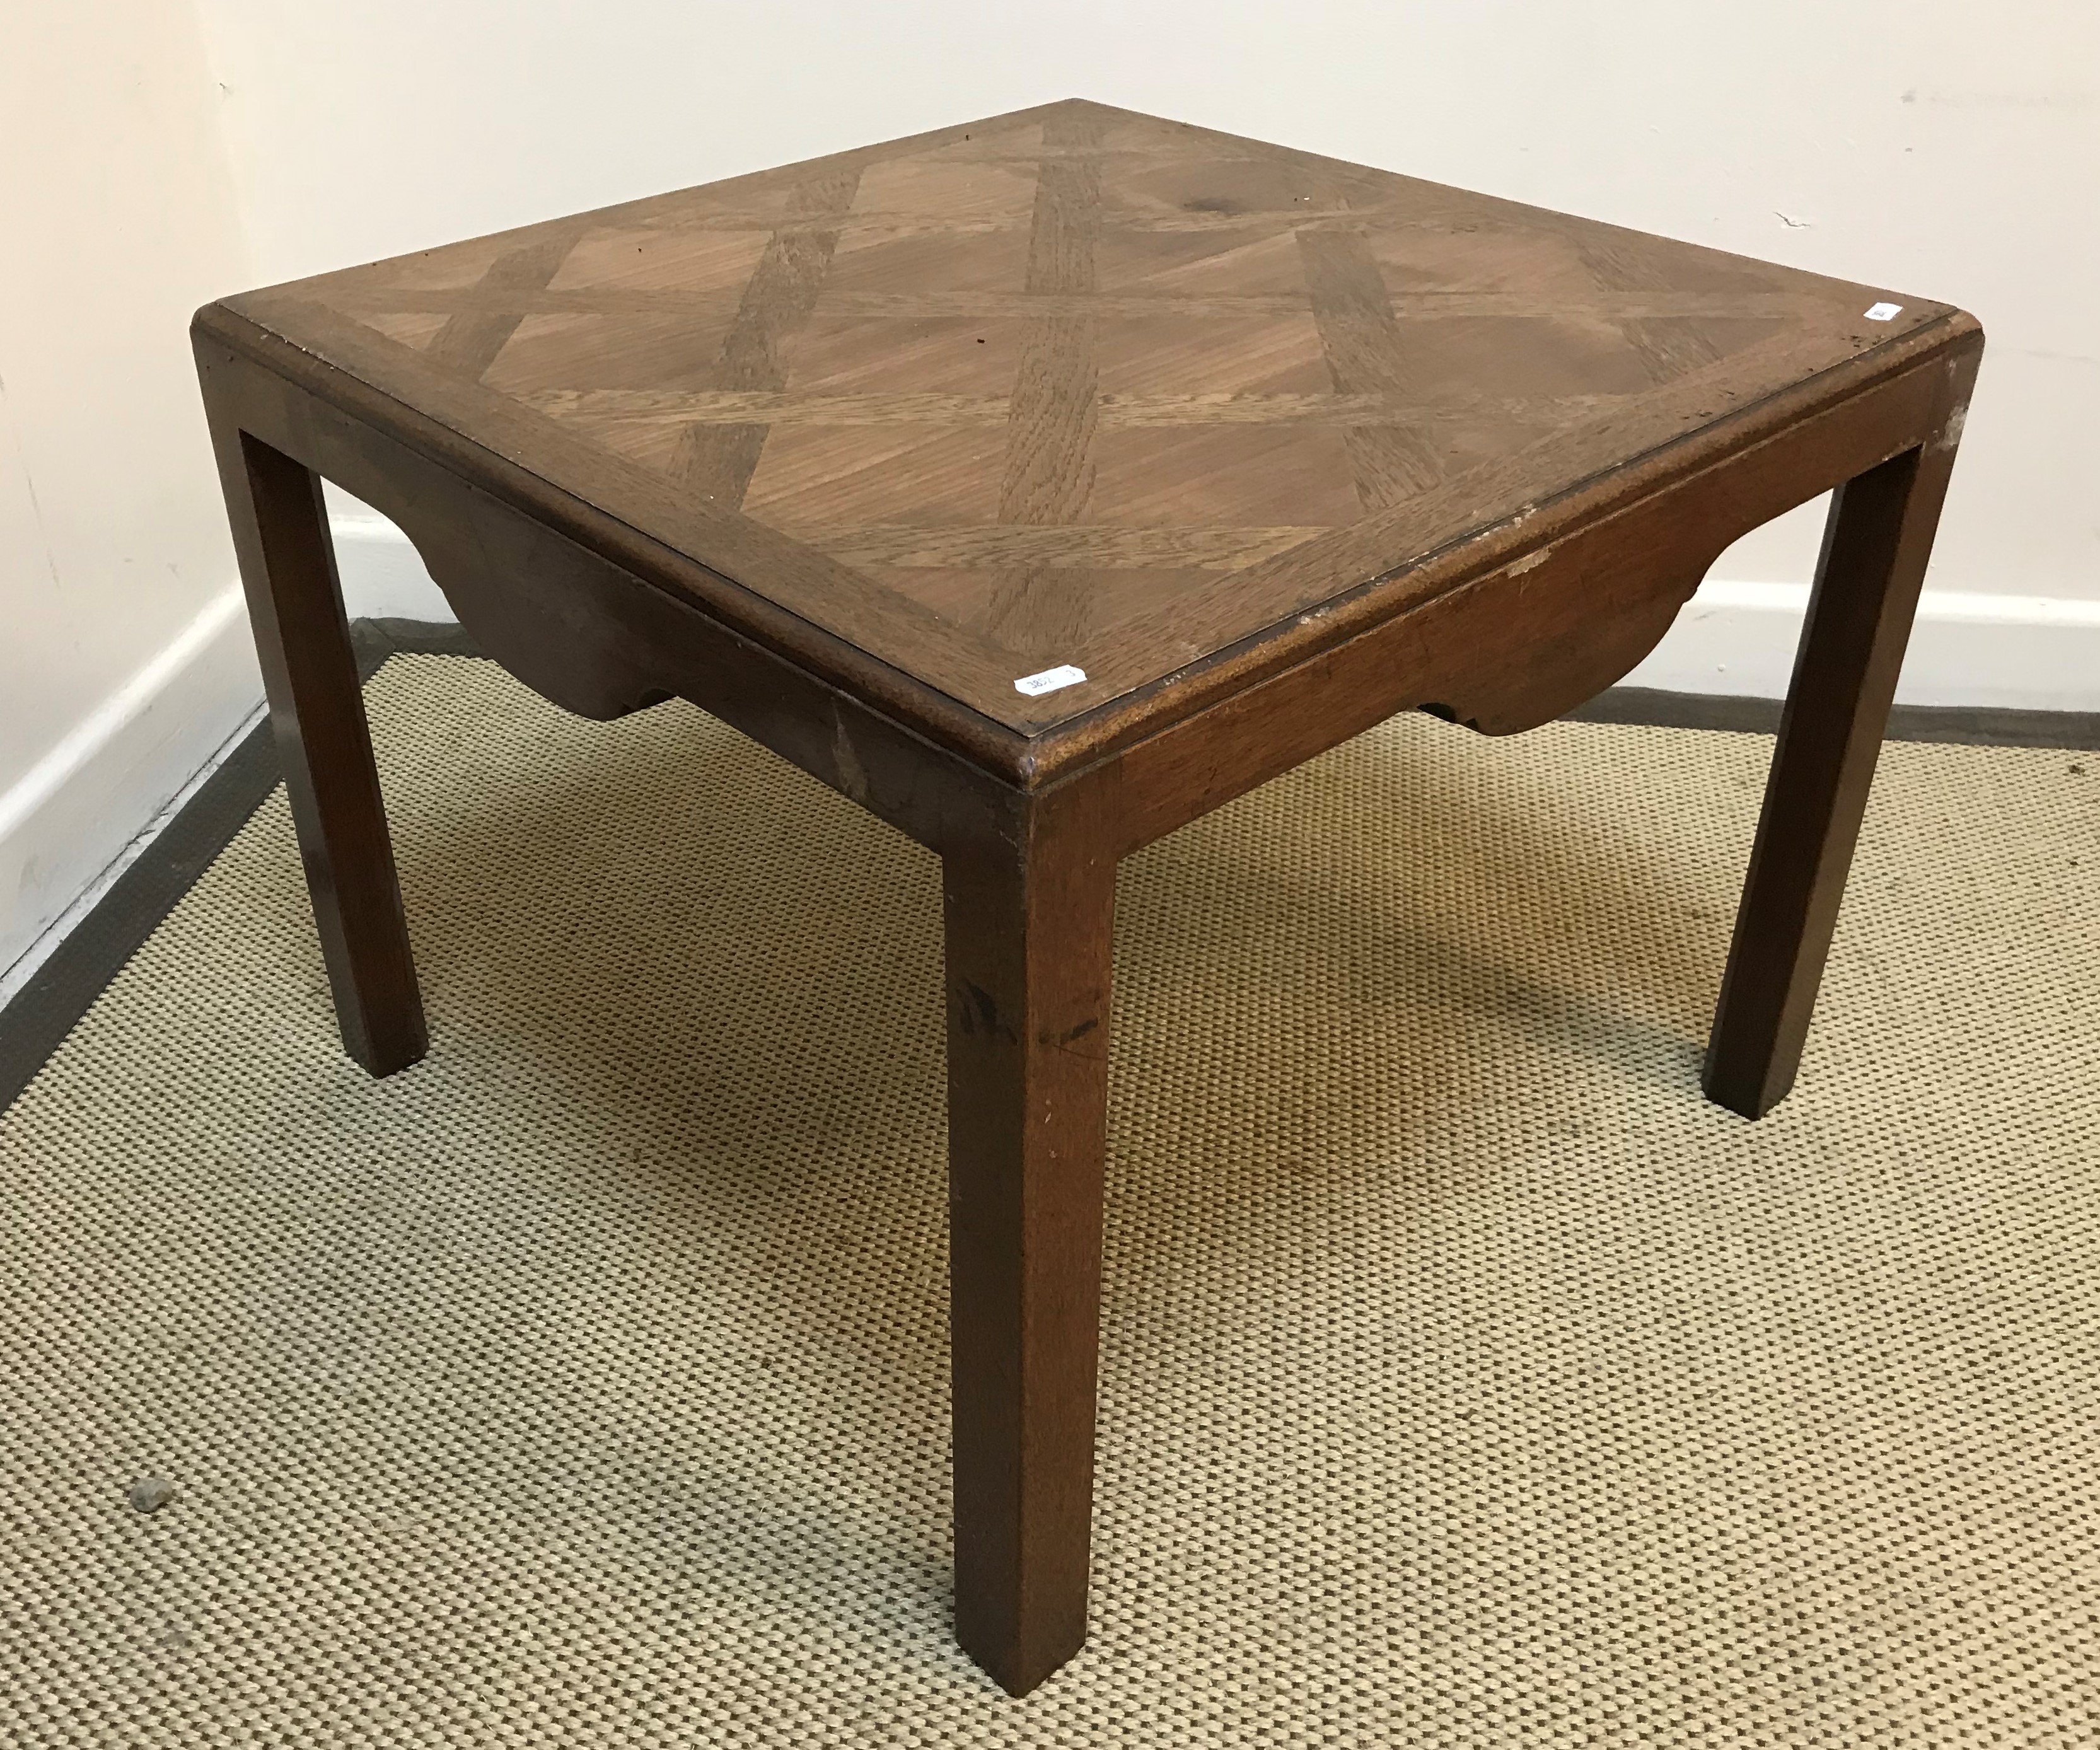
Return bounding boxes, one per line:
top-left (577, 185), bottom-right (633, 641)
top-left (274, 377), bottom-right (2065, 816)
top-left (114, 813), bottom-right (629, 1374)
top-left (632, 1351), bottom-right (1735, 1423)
top-left (193, 103), bottom-right (1982, 1693)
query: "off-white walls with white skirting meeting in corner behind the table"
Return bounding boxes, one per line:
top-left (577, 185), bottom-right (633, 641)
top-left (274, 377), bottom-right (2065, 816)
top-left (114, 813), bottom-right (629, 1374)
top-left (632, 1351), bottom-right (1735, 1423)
top-left (0, 0), bottom-right (2100, 983)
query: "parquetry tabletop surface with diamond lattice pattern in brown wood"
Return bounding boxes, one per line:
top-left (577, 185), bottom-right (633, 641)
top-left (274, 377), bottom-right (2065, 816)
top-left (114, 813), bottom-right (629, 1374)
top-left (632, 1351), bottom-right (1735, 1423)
top-left (235, 103), bottom-right (1940, 725)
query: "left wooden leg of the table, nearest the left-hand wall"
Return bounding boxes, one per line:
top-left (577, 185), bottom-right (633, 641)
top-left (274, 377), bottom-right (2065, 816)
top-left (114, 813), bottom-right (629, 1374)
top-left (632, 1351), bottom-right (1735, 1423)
top-left (212, 414), bottom-right (429, 1075)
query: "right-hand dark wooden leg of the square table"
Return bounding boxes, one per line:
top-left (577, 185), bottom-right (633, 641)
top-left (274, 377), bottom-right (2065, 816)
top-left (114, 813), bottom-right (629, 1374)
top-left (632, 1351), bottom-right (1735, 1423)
top-left (1705, 368), bottom-right (1974, 1118)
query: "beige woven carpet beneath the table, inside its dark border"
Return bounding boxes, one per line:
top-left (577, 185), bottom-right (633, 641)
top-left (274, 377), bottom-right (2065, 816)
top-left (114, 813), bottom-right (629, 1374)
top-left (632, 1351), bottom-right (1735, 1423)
top-left (0, 658), bottom-right (2100, 1746)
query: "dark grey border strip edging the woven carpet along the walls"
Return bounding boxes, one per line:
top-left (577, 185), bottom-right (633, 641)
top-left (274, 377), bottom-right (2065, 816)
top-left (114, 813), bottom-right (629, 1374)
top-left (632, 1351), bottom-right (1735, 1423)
top-left (0, 620), bottom-right (2100, 1113)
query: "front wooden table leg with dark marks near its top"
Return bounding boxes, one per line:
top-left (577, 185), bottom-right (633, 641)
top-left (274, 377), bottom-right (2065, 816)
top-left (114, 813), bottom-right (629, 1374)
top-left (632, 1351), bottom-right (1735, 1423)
top-left (943, 809), bottom-right (1115, 1695)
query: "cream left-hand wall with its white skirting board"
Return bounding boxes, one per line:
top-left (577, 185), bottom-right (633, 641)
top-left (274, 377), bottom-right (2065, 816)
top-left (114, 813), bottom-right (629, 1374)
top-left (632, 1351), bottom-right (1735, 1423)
top-left (0, 0), bottom-right (262, 973)
